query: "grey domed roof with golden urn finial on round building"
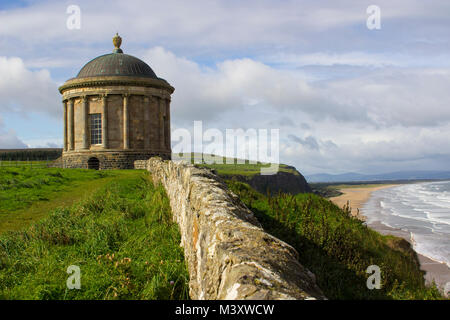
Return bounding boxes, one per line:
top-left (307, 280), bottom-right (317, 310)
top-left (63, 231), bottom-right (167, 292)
top-left (77, 34), bottom-right (159, 79)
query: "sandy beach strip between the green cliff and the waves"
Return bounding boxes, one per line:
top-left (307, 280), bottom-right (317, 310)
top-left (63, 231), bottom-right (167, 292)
top-left (329, 184), bottom-right (450, 291)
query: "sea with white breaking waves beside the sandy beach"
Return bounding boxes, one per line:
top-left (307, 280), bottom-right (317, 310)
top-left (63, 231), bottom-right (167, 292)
top-left (361, 181), bottom-right (450, 267)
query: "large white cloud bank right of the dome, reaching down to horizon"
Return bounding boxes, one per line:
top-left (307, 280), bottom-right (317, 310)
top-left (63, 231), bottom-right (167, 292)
top-left (145, 48), bottom-right (450, 172)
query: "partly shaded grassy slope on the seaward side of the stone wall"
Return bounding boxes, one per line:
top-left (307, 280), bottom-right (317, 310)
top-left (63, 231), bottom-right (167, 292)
top-left (227, 180), bottom-right (442, 300)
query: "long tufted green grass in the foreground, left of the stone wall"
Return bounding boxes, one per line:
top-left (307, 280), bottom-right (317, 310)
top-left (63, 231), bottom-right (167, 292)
top-left (0, 170), bottom-right (188, 299)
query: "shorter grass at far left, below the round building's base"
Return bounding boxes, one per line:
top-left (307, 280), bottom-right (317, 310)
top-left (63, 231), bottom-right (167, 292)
top-left (0, 167), bottom-right (129, 233)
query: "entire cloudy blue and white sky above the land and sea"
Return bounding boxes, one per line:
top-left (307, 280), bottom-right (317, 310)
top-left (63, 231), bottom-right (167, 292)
top-left (0, 0), bottom-right (450, 174)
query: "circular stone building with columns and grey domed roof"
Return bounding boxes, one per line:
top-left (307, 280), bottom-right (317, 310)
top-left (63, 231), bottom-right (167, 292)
top-left (59, 34), bottom-right (174, 169)
